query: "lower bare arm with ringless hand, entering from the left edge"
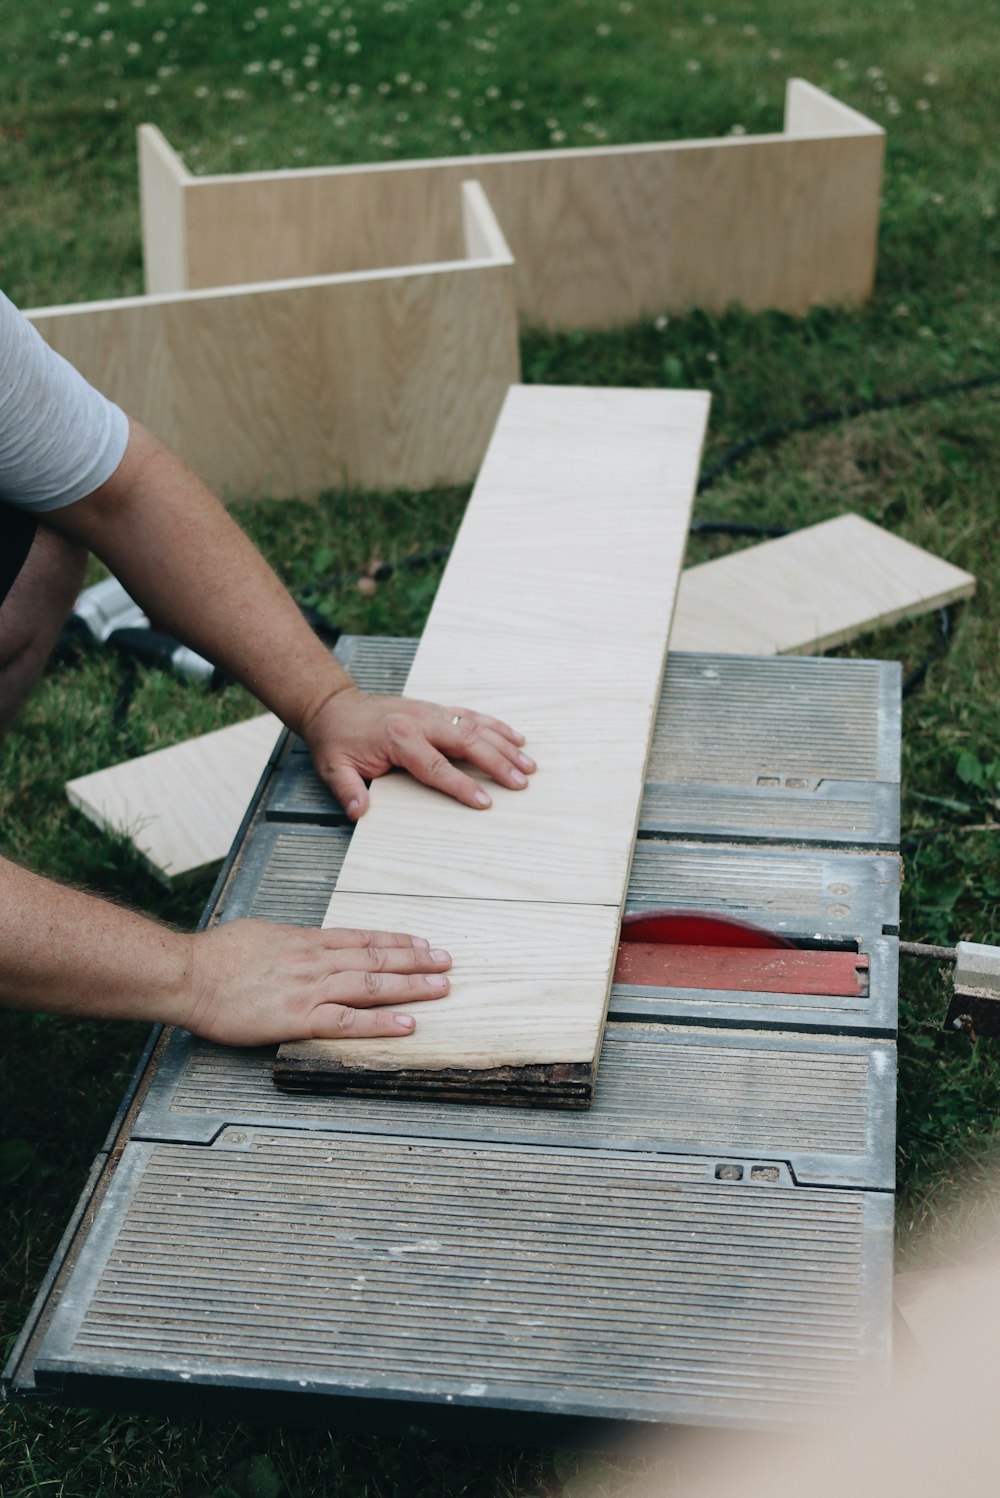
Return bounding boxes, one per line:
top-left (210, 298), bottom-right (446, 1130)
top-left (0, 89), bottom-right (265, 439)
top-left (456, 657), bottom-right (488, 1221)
top-left (0, 858), bottom-right (451, 1046)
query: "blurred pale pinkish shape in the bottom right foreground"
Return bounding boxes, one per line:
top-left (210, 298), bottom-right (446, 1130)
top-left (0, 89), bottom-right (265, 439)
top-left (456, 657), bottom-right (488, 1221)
top-left (566, 1171), bottom-right (1000, 1498)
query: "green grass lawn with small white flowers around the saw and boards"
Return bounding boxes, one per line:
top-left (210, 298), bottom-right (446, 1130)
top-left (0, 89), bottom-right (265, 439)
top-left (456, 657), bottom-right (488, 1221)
top-left (0, 0), bottom-right (1000, 1498)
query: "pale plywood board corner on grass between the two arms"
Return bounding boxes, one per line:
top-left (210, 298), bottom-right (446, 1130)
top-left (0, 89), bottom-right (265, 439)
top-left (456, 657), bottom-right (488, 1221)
top-left (66, 713), bottom-right (281, 884)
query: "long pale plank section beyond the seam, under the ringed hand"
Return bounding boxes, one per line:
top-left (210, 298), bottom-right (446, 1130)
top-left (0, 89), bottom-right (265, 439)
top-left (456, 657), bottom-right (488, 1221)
top-left (338, 386), bottom-right (708, 906)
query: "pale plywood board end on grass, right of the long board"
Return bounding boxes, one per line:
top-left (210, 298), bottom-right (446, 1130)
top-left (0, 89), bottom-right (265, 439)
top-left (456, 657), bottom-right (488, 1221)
top-left (671, 515), bottom-right (976, 655)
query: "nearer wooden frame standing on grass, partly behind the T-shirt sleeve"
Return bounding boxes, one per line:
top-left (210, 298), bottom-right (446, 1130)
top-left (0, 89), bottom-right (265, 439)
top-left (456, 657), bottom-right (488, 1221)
top-left (28, 187), bottom-right (519, 499)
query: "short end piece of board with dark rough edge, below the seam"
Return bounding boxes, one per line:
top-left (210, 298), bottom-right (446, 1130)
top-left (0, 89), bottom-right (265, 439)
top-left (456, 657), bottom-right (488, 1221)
top-left (274, 893), bottom-right (618, 1107)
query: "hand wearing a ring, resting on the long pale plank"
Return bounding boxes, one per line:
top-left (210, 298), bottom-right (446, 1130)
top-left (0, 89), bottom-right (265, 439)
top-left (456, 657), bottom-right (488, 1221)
top-left (302, 686), bottom-right (534, 822)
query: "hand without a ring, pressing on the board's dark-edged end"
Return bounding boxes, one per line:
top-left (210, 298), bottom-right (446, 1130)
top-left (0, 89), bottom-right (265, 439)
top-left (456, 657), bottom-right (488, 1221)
top-left (178, 921), bottom-right (451, 1046)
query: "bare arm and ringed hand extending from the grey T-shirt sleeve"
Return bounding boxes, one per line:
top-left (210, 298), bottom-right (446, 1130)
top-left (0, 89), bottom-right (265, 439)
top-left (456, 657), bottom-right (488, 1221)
top-left (46, 422), bottom-right (534, 816)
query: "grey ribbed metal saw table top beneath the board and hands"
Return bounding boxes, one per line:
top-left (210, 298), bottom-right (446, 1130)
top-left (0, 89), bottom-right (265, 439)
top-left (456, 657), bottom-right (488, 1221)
top-left (4, 638), bottom-right (900, 1444)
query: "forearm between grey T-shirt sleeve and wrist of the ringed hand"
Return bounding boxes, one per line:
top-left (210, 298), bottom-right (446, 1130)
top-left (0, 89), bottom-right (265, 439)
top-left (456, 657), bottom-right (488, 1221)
top-left (48, 424), bottom-right (352, 731)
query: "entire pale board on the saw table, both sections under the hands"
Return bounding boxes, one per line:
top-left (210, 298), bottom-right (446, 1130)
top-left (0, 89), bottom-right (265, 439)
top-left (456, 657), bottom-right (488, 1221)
top-left (275, 386), bottom-right (708, 1106)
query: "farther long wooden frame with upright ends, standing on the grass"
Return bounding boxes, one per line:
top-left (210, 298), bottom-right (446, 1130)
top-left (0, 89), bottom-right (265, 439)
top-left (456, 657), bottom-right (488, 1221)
top-left (139, 79), bottom-right (885, 327)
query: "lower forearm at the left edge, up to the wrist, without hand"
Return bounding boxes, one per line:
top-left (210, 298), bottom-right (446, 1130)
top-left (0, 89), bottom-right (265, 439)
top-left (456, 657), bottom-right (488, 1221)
top-left (0, 860), bottom-right (193, 1023)
